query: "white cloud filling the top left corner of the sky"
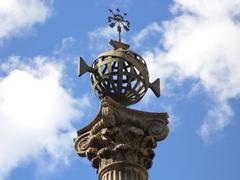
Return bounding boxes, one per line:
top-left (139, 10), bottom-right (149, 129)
top-left (0, 0), bottom-right (52, 41)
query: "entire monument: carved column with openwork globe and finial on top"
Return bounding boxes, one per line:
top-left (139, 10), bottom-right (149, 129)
top-left (74, 9), bottom-right (169, 180)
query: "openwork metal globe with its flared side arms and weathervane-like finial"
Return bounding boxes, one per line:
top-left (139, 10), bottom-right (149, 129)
top-left (78, 9), bottom-right (160, 106)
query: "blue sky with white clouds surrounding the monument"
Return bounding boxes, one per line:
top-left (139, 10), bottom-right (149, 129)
top-left (0, 0), bottom-right (240, 180)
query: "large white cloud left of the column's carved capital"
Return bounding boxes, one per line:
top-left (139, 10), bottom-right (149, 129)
top-left (0, 56), bottom-right (89, 180)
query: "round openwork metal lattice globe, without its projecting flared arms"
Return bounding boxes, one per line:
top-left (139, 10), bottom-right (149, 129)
top-left (91, 49), bottom-right (149, 105)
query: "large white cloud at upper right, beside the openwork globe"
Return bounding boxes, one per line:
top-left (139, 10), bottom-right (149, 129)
top-left (136, 0), bottom-right (240, 140)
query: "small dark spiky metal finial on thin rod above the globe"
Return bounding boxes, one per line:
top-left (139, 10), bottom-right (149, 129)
top-left (108, 8), bottom-right (130, 42)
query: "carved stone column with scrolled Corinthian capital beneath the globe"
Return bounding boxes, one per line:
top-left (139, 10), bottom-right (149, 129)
top-left (74, 97), bottom-right (168, 180)
